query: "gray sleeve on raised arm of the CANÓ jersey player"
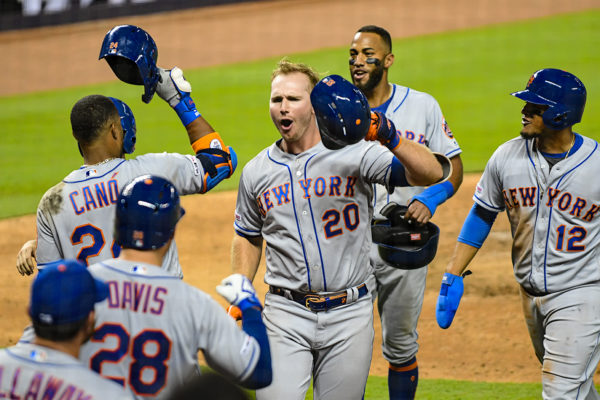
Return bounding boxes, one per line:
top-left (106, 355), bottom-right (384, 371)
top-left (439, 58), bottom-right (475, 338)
top-left (130, 153), bottom-right (206, 195)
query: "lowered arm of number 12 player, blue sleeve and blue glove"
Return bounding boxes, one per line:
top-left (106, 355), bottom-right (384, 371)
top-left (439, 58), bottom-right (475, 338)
top-left (435, 204), bottom-right (497, 329)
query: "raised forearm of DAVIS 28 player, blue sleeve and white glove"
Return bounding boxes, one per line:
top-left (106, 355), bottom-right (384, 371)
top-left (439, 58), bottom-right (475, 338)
top-left (217, 274), bottom-right (273, 389)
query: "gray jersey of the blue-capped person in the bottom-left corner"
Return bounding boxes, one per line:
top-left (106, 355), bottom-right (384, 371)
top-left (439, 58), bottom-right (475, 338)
top-left (0, 343), bottom-right (132, 400)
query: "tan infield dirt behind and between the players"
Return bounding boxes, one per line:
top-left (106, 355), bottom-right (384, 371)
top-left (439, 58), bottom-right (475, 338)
top-left (0, 0), bottom-right (600, 382)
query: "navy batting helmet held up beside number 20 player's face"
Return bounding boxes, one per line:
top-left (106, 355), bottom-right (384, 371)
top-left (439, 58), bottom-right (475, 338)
top-left (310, 75), bottom-right (371, 150)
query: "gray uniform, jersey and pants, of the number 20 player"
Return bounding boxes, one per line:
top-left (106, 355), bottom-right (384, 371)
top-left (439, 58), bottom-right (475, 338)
top-left (234, 141), bottom-right (393, 400)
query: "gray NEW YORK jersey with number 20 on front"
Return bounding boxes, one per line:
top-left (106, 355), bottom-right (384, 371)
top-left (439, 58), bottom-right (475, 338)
top-left (234, 141), bottom-right (393, 292)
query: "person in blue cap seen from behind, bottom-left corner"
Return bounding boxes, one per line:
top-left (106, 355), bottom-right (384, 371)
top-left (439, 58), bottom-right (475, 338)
top-left (0, 260), bottom-right (132, 400)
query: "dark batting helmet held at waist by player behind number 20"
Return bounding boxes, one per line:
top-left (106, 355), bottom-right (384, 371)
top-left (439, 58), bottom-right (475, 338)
top-left (371, 202), bottom-right (440, 269)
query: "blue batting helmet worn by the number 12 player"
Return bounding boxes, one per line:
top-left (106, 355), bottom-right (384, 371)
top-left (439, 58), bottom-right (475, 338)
top-left (511, 68), bottom-right (587, 129)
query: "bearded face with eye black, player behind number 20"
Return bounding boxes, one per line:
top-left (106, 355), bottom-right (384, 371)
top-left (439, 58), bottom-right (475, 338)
top-left (350, 32), bottom-right (389, 93)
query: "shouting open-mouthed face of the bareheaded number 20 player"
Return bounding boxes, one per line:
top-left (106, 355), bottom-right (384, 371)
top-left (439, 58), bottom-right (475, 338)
top-left (269, 72), bottom-right (315, 143)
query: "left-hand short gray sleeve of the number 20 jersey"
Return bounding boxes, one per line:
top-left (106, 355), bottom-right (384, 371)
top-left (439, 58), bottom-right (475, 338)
top-left (233, 168), bottom-right (263, 237)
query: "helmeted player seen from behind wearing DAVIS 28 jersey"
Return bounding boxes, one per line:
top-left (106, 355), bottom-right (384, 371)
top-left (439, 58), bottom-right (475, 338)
top-left (19, 175), bottom-right (271, 399)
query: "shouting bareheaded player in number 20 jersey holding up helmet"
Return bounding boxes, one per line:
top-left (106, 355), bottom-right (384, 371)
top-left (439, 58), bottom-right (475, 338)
top-left (232, 60), bottom-right (442, 400)
